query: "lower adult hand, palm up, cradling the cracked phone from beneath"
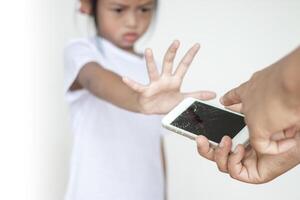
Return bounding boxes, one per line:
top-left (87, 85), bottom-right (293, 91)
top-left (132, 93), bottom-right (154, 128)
top-left (197, 132), bottom-right (300, 184)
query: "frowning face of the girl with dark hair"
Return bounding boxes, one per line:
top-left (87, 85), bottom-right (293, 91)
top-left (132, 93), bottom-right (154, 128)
top-left (82, 0), bottom-right (156, 51)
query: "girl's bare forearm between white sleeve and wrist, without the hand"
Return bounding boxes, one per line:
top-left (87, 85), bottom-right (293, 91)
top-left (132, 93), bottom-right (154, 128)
top-left (78, 62), bottom-right (141, 112)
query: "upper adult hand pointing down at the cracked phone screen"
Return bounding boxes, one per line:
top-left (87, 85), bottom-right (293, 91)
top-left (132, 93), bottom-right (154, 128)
top-left (221, 49), bottom-right (300, 154)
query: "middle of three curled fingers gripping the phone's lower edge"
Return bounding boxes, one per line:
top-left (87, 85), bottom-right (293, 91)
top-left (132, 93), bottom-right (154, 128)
top-left (214, 136), bottom-right (232, 173)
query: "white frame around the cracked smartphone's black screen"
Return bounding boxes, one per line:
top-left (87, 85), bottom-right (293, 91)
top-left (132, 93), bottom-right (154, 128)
top-left (162, 97), bottom-right (249, 151)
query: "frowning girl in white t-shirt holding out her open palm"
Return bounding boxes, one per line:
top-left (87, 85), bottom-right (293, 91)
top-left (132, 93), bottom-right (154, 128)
top-left (65, 0), bottom-right (215, 200)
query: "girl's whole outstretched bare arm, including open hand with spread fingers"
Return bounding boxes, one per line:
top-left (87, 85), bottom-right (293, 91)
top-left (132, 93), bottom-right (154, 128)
top-left (71, 41), bottom-right (215, 114)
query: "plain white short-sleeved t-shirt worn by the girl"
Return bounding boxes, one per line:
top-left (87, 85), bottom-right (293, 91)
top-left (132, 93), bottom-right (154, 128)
top-left (64, 37), bottom-right (164, 200)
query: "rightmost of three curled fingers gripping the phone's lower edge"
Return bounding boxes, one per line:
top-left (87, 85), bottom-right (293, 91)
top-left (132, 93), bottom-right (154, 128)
top-left (228, 145), bottom-right (245, 180)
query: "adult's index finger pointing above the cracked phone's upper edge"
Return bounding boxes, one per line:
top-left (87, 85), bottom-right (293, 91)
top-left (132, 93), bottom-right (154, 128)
top-left (220, 82), bottom-right (247, 106)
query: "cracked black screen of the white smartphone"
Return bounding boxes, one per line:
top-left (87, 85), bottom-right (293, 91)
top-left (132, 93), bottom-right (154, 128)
top-left (171, 101), bottom-right (245, 143)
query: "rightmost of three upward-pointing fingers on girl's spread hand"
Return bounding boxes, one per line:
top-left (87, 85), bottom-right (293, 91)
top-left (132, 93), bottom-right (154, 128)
top-left (175, 44), bottom-right (200, 79)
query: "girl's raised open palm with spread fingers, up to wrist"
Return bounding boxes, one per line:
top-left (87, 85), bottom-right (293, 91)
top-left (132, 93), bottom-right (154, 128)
top-left (123, 40), bottom-right (216, 114)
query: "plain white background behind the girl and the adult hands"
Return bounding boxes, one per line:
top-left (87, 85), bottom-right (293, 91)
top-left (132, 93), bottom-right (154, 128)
top-left (0, 0), bottom-right (300, 200)
